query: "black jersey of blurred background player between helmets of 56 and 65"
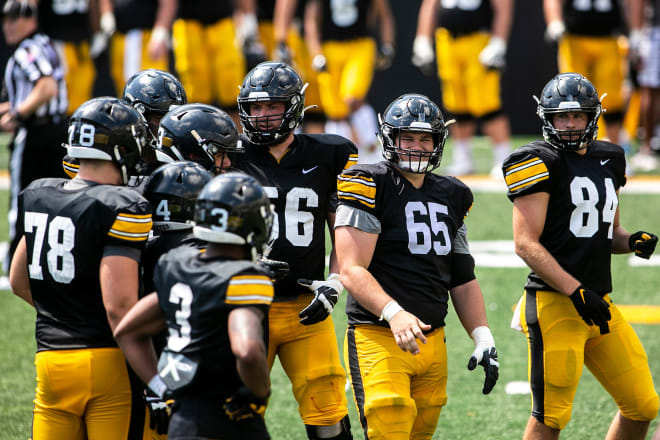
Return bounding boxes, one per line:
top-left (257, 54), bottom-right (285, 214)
top-left (321, 0), bottom-right (371, 41)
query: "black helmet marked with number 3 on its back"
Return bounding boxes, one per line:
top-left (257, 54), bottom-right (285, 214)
top-left (193, 172), bottom-right (273, 259)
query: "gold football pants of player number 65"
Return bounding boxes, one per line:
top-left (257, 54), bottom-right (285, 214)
top-left (344, 325), bottom-right (447, 440)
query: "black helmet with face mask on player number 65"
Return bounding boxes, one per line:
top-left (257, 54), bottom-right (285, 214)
top-left (378, 93), bottom-right (453, 174)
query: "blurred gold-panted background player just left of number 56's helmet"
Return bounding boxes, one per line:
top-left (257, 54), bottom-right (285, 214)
top-left (172, 0), bottom-right (265, 125)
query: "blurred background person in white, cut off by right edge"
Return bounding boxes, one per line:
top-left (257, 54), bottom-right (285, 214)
top-left (629, 0), bottom-right (660, 172)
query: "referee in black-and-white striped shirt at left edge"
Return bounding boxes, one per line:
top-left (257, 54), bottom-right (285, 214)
top-left (0, 0), bottom-right (68, 272)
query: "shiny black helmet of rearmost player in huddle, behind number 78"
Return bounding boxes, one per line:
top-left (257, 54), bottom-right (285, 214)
top-left (122, 69), bottom-right (188, 145)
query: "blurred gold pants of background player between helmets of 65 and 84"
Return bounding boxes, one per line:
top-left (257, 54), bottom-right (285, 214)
top-left (435, 28), bottom-right (501, 118)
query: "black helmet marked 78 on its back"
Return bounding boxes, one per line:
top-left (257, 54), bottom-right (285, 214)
top-left (65, 97), bottom-right (147, 185)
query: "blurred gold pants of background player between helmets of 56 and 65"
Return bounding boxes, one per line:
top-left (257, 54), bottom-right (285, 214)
top-left (318, 38), bottom-right (376, 120)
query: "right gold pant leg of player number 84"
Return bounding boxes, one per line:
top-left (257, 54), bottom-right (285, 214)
top-left (584, 297), bottom-right (658, 421)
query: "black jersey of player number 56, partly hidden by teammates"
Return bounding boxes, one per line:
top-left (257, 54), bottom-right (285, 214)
top-left (235, 134), bottom-right (357, 299)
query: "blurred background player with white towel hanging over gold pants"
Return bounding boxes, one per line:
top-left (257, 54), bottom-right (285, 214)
top-left (106, 0), bottom-right (177, 93)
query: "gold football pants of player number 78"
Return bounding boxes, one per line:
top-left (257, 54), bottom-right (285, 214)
top-left (32, 348), bottom-right (131, 440)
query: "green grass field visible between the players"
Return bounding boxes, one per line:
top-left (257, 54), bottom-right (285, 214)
top-left (0, 136), bottom-right (660, 440)
